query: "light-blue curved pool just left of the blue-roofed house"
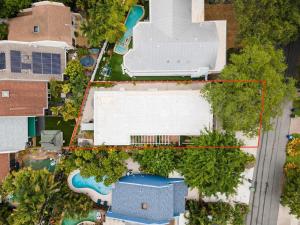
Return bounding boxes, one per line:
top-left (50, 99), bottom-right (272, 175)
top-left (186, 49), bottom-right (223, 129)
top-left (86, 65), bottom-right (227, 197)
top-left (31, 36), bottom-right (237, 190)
top-left (72, 172), bottom-right (112, 195)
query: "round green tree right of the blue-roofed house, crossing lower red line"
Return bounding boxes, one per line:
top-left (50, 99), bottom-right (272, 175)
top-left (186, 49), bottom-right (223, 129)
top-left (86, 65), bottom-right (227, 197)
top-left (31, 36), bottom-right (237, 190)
top-left (179, 131), bottom-right (254, 196)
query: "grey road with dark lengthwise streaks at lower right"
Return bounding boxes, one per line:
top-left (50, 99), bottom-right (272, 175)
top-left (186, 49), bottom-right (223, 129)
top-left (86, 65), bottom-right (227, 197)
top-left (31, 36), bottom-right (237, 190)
top-left (247, 103), bottom-right (291, 225)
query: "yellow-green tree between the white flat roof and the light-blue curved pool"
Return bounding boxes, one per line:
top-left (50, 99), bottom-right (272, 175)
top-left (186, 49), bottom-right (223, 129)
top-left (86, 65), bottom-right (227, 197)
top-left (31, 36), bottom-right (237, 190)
top-left (61, 150), bottom-right (128, 185)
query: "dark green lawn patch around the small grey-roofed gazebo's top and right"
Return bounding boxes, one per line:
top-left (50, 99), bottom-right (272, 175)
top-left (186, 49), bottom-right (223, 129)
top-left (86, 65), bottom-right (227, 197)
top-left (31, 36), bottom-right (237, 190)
top-left (45, 116), bottom-right (75, 146)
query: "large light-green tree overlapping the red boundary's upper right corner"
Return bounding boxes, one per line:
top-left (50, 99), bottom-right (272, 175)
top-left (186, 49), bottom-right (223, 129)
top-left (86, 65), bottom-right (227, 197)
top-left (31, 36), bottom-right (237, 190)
top-left (203, 44), bottom-right (295, 135)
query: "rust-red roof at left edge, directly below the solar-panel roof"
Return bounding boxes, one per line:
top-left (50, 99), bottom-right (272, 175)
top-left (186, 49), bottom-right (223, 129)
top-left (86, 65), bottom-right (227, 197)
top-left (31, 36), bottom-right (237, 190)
top-left (0, 81), bottom-right (48, 116)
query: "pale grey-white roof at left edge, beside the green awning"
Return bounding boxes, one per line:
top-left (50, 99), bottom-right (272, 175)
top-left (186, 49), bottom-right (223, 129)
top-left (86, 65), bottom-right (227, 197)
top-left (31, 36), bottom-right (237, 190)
top-left (0, 116), bottom-right (28, 153)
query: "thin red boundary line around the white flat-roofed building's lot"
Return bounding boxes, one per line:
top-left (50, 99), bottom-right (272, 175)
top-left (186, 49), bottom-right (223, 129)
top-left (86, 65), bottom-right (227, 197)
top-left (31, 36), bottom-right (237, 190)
top-left (69, 80), bottom-right (266, 150)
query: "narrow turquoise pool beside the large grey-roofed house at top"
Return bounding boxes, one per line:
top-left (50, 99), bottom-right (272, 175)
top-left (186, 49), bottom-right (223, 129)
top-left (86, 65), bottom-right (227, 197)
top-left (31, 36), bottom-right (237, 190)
top-left (114, 5), bottom-right (145, 55)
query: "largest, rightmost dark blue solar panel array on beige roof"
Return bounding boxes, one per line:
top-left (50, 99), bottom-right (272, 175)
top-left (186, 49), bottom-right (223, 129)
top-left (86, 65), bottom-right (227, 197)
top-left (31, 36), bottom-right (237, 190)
top-left (32, 52), bottom-right (61, 74)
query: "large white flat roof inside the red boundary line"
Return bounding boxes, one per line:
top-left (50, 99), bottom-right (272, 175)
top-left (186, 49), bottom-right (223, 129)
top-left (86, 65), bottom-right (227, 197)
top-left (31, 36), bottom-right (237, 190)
top-left (94, 90), bottom-right (213, 145)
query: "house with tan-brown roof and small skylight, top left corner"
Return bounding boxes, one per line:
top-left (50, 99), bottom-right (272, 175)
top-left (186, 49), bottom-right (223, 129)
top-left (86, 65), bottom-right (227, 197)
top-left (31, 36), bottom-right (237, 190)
top-left (8, 1), bottom-right (81, 47)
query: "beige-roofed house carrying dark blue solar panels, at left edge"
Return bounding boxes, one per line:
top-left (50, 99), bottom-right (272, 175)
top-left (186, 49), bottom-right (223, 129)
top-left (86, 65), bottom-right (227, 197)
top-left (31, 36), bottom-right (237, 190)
top-left (0, 41), bottom-right (66, 81)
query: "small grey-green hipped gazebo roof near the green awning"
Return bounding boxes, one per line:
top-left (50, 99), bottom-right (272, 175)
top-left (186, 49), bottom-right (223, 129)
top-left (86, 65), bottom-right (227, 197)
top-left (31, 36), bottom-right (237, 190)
top-left (40, 130), bottom-right (64, 151)
